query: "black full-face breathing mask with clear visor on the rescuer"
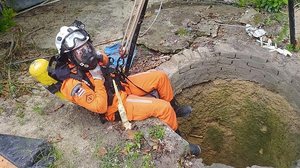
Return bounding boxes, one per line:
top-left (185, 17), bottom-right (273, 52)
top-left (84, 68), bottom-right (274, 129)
top-left (72, 42), bottom-right (98, 70)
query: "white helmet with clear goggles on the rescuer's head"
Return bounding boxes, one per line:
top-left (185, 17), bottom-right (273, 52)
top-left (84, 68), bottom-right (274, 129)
top-left (55, 26), bottom-right (89, 53)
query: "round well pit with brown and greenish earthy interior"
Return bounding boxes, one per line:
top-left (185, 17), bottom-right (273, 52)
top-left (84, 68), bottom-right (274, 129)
top-left (176, 80), bottom-right (300, 168)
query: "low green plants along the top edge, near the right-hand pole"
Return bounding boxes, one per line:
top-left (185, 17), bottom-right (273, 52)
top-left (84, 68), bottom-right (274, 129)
top-left (238, 0), bottom-right (288, 12)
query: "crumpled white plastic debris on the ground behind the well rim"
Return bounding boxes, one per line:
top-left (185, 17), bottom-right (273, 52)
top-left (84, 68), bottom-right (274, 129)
top-left (246, 24), bottom-right (292, 56)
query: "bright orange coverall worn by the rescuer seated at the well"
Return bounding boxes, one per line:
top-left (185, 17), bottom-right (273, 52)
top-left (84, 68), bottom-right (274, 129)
top-left (60, 55), bottom-right (178, 130)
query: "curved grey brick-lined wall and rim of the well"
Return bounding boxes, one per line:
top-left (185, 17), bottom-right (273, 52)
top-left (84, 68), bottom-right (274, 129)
top-left (157, 43), bottom-right (300, 111)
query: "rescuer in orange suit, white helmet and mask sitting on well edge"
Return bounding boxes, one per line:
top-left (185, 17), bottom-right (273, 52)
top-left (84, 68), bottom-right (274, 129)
top-left (55, 26), bottom-right (200, 155)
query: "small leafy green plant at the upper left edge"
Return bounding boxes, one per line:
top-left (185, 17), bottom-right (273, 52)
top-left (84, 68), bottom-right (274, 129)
top-left (0, 7), bottom-right (16, 32)
